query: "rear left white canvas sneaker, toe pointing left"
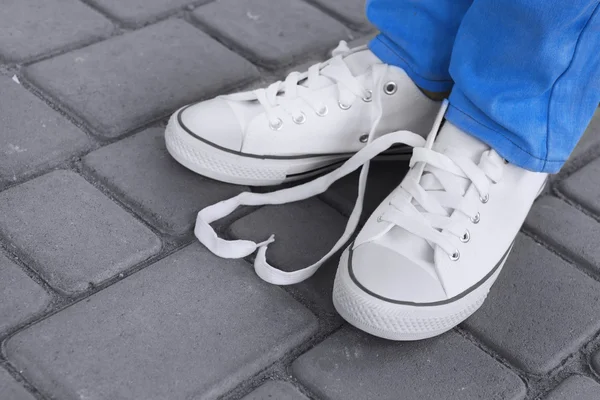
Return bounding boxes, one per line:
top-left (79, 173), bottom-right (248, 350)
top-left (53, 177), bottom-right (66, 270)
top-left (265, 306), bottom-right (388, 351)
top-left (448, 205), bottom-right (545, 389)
top-left (165, 42), bottom-right (441, 186)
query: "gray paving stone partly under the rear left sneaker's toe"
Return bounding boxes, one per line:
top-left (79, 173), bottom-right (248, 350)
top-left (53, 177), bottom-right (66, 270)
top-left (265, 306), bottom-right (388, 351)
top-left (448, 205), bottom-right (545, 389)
top-left (83, 128), bottom-right (247, 234)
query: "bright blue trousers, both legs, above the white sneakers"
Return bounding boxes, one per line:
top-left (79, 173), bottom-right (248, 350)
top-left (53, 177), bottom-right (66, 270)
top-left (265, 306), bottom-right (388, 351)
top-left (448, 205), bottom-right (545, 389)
top-left (367, 0), bottom-right (600, 173)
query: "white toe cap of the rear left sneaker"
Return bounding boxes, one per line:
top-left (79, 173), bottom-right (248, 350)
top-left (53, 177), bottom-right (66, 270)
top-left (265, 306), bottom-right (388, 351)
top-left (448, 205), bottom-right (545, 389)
top-left (179, 97), bottom-right (243, 151)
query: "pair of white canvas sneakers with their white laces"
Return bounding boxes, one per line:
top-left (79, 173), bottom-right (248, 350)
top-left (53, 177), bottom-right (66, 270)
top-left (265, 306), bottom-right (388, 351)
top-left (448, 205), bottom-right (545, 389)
top-left (165, 42), bottom-right (547, 340)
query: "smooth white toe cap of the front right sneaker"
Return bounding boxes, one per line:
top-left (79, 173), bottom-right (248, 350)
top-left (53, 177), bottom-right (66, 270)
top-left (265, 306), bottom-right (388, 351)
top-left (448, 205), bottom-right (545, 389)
top-left (348, 242), bottom-right (447, 303)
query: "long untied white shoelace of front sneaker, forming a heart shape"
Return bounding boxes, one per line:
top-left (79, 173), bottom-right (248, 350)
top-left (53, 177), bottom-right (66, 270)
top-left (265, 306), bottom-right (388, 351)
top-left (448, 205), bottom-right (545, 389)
top-left (194, 86), bottom-right (502, 285)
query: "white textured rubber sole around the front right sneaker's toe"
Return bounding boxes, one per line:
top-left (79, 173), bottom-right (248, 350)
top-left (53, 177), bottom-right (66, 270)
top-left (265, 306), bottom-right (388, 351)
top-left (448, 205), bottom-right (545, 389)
top-left (333, 248), bottom-right (510, 341)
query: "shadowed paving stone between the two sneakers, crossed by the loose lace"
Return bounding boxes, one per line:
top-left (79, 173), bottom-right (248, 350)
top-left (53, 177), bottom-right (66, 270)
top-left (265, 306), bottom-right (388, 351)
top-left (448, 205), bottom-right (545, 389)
top-left (322, 161), bottom-right (408, 222)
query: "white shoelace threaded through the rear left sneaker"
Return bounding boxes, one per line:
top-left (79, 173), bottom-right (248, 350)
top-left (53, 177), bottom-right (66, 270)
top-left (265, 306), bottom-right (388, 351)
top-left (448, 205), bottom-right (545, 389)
top-left (224, 40), bottom-right (372, 129)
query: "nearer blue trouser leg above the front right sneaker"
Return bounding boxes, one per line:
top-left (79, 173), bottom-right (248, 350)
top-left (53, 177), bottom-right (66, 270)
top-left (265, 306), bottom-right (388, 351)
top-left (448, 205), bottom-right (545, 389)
top-left (447, 0), bottom-right (600, 173)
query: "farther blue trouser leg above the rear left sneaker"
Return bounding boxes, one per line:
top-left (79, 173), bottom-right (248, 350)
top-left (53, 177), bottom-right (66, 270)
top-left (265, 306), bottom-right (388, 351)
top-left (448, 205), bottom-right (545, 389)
top-left (366, 0), bottom-right (473, 92)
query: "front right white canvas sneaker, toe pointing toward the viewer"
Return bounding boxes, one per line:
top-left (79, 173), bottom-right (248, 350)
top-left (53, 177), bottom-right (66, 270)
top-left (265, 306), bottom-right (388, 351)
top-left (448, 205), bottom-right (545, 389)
top-left (333, 118), bottom-right (547, 340)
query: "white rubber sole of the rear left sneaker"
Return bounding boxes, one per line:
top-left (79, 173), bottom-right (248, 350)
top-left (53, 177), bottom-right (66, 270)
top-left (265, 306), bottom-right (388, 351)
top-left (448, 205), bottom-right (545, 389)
top-left (165, 112), bottom-right (412, 186)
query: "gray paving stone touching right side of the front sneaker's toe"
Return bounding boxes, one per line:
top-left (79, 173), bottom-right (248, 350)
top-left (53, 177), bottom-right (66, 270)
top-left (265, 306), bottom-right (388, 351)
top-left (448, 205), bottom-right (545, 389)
top-left (464, 235), bottom-right (600, 374)
